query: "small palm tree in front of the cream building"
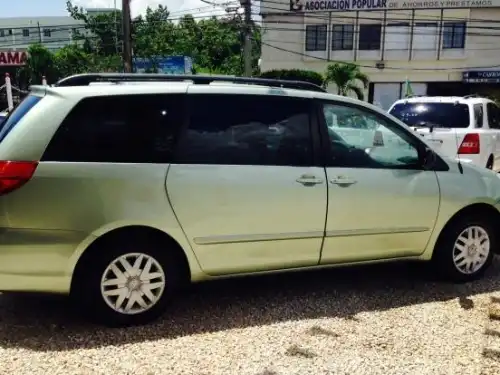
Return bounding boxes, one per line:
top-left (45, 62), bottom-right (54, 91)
top-left (323, 63), bottom-right (370, 100)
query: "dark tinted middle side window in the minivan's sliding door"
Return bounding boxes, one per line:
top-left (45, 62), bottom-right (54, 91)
top-left (176, 94), bottom-right (313, 166)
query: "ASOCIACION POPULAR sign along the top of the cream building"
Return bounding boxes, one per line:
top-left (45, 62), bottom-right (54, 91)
top-left (292, 0), bottom-right (494, 12)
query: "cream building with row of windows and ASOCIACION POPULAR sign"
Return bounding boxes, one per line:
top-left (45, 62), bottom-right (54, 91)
top-left (261, 0), bottom-right (500, 109)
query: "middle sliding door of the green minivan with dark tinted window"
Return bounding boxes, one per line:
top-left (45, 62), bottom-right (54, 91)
top-left (166, 90), bottom-right (327, 275)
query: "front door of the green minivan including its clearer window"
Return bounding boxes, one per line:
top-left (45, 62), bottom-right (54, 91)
top-left (321, 102), bottom-right (439, 264)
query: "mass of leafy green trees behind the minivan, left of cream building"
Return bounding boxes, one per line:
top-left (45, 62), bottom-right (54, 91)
top-left (38, 0), bottom-right (261, 77)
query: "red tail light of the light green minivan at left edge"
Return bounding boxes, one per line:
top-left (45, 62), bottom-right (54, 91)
top-left (0, 161), bottom-right (38, 195)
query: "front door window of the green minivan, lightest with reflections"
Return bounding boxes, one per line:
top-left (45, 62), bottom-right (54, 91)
top-left (323, 103), bottom-right (421, 169)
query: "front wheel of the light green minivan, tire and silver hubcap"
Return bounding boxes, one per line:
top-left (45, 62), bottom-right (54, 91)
top-left (432, 214), bottom-right (498, 283)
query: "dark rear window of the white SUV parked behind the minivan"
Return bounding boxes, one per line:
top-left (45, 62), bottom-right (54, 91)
top-left (389, 102), bottom-right (469, 128)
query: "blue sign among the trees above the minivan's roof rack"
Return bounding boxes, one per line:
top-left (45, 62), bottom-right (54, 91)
top-left (132, 56), bottom-right (193, 74)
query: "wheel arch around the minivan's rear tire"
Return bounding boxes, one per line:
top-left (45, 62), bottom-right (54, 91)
top-left (70, 225), bottom-right (191, 291)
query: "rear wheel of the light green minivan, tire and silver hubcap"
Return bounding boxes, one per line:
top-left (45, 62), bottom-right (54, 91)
top-left (71, 239), bottom-right (181, 327)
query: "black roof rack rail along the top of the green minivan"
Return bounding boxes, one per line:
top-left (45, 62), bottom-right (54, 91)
top-left (54, 73), bottom-right (326, 92)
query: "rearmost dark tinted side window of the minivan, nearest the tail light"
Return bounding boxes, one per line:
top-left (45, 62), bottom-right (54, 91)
top-left (43, 94), bottom-right (184, 163)
